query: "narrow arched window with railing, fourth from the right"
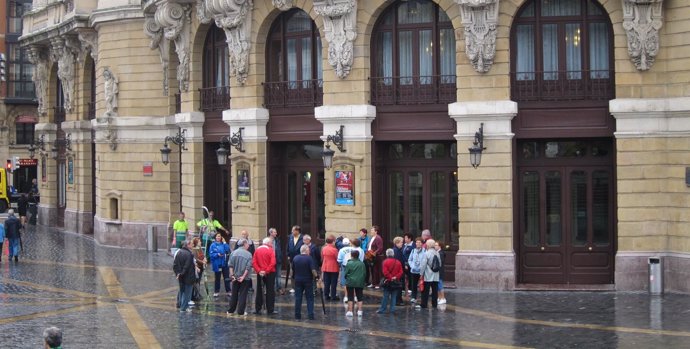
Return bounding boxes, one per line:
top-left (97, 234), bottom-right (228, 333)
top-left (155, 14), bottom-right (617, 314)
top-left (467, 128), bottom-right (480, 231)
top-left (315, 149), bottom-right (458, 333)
top-left (200, 24), bottom-right (230, 113)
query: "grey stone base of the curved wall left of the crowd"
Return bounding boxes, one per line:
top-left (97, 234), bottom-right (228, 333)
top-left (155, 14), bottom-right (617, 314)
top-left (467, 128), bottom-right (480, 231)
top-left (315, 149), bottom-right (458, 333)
top-left (94, 216), bottom-right (170, 251)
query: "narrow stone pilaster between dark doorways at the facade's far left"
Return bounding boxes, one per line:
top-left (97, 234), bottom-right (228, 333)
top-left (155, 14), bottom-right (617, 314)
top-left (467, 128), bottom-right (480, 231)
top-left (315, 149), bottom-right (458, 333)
top-left (62, 121), bottom-right (95, 234)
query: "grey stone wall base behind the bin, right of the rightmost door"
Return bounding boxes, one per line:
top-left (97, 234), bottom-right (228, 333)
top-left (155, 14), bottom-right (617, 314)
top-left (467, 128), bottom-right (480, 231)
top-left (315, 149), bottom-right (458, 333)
top-left (615, 252), bottom-right (690, 293)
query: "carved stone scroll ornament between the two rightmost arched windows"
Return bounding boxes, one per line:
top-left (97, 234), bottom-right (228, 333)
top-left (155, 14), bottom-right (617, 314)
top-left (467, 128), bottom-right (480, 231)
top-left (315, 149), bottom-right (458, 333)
top-left (455, 0), bottom-right (500, 73)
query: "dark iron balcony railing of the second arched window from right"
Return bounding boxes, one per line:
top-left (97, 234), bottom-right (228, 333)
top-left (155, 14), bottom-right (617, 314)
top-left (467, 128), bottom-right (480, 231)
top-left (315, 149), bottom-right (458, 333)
top-left (369, 75), bottom-right (457, 105)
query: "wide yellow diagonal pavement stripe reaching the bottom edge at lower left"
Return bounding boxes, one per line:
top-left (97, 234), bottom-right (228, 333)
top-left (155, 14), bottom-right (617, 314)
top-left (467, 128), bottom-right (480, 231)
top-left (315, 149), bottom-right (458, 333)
top-left (98, 267), bottom-right (161, 348)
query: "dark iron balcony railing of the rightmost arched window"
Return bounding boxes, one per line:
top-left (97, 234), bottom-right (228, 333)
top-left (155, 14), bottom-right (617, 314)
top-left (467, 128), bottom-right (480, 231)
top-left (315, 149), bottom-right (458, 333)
top-left (510, 70), bottom-right (614, 102)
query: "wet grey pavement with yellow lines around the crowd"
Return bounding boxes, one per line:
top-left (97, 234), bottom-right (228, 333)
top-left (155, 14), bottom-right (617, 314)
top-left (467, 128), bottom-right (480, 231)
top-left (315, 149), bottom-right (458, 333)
top-left (0, 224), bottom-right (690, 348)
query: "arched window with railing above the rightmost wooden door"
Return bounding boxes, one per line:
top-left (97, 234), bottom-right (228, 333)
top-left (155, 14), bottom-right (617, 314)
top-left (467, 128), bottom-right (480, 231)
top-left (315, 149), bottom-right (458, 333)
top-left (511, 0), bottom-right (614, 101)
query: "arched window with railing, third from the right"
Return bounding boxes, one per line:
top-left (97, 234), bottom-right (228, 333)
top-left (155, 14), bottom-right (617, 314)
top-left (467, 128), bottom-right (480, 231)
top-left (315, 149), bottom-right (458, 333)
top-left (263, 9), bottom-right (323, 108)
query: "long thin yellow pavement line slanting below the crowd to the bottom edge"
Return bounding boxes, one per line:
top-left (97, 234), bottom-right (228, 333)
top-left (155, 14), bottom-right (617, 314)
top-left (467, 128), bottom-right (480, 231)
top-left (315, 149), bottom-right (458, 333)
top-left (141, 303), bottom-right (526, 349)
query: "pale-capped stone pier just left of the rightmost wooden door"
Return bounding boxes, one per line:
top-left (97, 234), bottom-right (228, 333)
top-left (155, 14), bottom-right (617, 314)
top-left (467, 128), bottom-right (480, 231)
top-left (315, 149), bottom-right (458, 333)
top-left (448, 100), bottom-right (517, 290)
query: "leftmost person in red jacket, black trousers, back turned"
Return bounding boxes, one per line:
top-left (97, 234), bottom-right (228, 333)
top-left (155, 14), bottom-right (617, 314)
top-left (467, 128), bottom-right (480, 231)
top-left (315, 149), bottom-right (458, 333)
top-left (252, 237), bottom-right (276, 315)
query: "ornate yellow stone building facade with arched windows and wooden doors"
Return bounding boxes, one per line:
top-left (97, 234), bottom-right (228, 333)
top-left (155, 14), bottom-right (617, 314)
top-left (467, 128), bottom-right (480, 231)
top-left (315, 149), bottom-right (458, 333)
top-left (20, 0), bottom-right (690, 292)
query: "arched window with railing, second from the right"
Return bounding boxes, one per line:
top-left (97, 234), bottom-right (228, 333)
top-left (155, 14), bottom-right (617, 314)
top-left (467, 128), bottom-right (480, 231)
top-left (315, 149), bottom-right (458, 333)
top-left (370, 0), bottom-right (456, 105)
